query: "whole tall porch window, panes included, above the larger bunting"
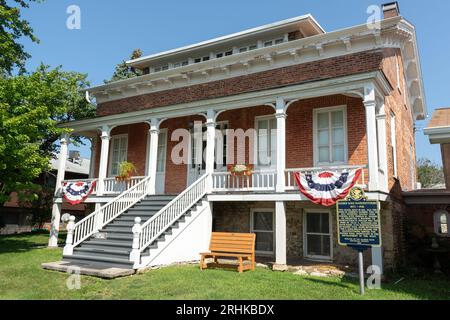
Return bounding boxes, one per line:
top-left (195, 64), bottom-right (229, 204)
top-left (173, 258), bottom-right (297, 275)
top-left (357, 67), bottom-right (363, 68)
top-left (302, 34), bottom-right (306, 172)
top-left (314, 107), bottom-right (347, 165)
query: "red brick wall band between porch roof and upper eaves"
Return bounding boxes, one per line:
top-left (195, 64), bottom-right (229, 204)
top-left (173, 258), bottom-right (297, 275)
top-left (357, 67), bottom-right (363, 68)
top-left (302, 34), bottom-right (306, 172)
top-left (97, 50), bottom-right (384, 116)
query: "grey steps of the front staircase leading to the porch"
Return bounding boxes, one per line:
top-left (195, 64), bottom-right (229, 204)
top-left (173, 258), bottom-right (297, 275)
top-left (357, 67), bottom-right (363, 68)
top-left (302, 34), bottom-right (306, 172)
top-left (63, 195), bottom-right (176, 269)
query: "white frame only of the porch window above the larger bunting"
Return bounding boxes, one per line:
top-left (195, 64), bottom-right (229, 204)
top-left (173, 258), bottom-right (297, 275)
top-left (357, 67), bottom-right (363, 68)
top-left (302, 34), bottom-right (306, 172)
top-left (313, 105), bottom-right (348, 167)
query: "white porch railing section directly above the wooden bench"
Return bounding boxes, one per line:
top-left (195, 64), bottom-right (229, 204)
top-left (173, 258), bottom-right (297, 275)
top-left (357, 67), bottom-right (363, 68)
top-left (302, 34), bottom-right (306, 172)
top-left (212, 170), bottom-right (277, 192)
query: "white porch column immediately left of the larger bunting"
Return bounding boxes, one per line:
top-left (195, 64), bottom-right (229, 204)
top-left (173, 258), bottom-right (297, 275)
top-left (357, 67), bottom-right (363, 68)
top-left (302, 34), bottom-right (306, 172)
top-left (275, 98), bottom-right (287, 193)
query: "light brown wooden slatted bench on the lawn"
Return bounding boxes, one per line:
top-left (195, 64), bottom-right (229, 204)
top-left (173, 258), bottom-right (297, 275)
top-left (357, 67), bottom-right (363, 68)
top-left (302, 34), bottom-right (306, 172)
top-left (200, 232), bottom-right (256, 273)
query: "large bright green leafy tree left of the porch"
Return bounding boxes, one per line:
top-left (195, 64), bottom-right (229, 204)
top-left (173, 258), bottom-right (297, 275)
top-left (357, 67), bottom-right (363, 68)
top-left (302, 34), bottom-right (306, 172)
top-left (0, 65), bottom-right (95, 207)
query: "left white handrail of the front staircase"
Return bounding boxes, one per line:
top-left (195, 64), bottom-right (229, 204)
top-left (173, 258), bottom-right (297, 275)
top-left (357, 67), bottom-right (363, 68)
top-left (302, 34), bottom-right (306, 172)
top-left (67, 177), bottom-right (151, 248)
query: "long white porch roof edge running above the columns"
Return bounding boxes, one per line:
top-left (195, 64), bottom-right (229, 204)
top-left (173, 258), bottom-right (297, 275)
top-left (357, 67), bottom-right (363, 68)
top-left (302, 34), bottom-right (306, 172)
top-left (60, 71), bottom-right (392, 134)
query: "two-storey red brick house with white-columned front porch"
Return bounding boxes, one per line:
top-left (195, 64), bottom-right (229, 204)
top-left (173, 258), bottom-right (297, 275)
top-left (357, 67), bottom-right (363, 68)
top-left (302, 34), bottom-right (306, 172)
top-left (50, 3), bottom-right (426, 269)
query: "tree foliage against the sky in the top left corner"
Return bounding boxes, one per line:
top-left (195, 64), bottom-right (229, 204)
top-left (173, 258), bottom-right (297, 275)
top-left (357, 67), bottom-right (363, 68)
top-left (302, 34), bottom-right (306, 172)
top-left (0, 0), bottom-right (41, 77)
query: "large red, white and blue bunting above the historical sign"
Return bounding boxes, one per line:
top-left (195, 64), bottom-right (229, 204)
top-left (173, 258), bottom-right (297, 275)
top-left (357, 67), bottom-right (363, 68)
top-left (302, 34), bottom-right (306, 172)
top-left (295, 169), bottom-right (362, 207)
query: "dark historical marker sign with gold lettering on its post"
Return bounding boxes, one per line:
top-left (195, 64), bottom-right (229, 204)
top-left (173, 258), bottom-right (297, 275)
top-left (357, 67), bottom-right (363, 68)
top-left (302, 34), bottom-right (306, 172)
top-left (337, 187), bottom-right (381, 295)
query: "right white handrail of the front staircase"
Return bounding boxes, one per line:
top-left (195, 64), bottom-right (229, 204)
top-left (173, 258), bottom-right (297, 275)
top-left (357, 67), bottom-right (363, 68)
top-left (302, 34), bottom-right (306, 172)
top-left (133, 174), bottom-right (209, 252)
